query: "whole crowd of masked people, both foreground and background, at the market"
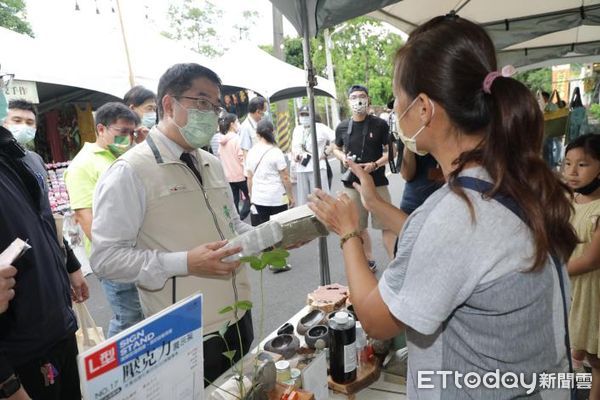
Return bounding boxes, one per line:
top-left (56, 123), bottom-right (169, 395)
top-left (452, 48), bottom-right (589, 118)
top-left (0, 14), bottom-right (600, 399)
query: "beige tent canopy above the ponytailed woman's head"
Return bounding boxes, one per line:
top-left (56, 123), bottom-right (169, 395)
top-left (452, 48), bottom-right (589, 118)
top-left (370, 0), bottom-right (600, 67)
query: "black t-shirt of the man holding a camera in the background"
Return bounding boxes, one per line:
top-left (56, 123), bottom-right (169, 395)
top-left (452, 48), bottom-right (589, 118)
top-left (335, 115), bottom-right (389, 187)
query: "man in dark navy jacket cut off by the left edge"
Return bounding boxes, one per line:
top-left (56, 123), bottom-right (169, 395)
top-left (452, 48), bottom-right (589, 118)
top-left (0, 90), bottom-right (87, 400)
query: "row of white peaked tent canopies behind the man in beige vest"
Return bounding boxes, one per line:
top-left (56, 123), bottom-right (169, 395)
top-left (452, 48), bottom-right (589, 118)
top-left (0, 23), bottom-right (336, 106)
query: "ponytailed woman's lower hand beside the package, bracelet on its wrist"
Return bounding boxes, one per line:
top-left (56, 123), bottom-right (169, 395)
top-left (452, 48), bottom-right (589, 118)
top-left (308, 189), bottom-right (360, 236)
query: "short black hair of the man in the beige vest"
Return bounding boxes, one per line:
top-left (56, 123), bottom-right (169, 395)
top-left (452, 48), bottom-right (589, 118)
top-left (156, 63), bottom-right (223, 119)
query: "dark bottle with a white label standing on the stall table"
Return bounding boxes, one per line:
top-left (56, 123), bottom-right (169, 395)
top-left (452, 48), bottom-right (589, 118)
top-left (329, 311), bottom-right (356, 383)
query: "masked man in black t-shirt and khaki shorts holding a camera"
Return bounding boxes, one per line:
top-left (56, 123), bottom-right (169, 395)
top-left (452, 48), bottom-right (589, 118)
top-left (333, 85), bottom-right (396, 271)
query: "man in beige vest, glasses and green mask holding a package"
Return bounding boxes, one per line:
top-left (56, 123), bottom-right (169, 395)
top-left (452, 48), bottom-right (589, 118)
top-left (90, 64), bottom-right (253, 381)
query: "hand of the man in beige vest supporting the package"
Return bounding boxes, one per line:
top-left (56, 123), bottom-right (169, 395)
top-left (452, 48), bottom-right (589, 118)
top-left (187, 240), bottom-right (242, 276)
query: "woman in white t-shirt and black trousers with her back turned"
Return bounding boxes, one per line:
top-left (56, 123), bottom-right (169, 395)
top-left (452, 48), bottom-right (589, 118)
top-left (245, 119), bottom-right (294, 226)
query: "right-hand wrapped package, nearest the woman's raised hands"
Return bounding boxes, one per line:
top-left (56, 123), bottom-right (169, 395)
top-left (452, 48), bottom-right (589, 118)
top-left (271, 205), bottom-right (329, 248)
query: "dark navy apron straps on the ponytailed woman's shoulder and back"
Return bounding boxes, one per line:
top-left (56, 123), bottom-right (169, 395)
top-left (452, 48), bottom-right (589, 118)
top-left (456, 176), bottom-right (573, 382)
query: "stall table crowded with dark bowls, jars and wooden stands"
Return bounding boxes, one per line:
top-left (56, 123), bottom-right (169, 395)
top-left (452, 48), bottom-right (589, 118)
top-left (205, 284), bottom-right (406, 400)
